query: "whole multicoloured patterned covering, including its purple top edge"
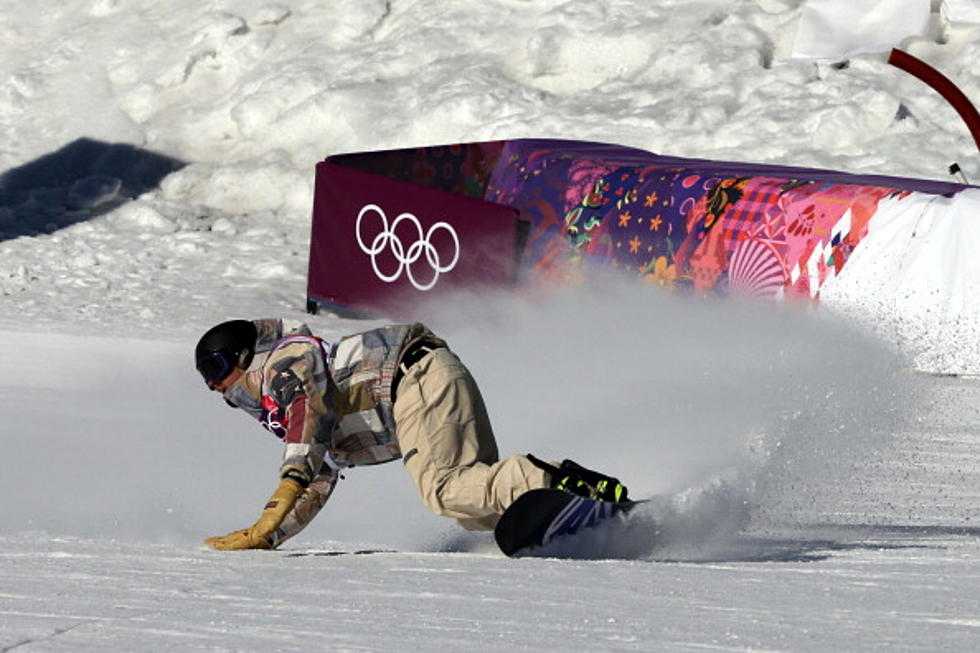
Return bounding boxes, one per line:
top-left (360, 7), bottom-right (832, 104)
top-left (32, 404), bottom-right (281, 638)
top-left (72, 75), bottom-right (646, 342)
top-left (311, 140), bottom-right (967, 310)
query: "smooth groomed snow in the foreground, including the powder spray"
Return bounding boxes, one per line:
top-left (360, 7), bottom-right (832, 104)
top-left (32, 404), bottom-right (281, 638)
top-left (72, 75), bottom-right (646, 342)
top-left (0, 300), bottom-right (980, 651)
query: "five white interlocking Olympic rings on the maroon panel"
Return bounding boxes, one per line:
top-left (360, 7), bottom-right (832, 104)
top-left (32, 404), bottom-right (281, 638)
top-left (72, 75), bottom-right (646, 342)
top-left (355, 204), bottom-right (459, 292)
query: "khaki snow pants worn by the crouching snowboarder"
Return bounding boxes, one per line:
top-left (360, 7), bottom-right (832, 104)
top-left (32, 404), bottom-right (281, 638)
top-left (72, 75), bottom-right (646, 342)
top-left (394, 349), bottom-right (548, 530)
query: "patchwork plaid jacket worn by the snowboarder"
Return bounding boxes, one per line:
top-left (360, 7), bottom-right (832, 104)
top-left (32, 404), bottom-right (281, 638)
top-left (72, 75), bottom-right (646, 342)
top-left (225, 319), bottom-right (444, 483)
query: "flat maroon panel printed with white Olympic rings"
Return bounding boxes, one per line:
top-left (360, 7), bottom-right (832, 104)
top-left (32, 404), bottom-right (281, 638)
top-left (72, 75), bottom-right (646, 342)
top-left (307, 160), bottom-right (519, 315)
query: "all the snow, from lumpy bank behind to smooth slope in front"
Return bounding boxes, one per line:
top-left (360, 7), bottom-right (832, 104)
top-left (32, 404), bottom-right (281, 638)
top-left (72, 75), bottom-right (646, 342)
top-left (0, 0), bottom-right (980, 651)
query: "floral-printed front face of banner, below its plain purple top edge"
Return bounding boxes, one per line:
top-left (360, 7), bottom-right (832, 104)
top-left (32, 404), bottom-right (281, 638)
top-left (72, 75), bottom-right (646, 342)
top-left (492, 146), bottom-right (901, 298)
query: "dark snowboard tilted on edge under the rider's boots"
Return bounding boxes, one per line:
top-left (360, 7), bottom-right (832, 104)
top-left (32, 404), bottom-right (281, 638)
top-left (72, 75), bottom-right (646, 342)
top-left (493, 489), bottom-right (638, 556)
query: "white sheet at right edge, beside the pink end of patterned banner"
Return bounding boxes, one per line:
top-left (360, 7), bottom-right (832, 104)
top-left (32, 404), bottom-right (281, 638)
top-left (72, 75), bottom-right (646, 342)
top-left (820, 188), bottom-right (980, 374)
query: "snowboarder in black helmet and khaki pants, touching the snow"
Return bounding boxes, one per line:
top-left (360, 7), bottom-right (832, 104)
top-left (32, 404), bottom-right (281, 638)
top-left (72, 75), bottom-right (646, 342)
top-left (195, 319), bottom-right (626, 549)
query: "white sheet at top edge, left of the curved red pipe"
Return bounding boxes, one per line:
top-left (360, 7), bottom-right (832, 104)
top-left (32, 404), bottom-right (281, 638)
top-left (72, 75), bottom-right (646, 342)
top-left (793, 0), bottom-right (932, 62)
